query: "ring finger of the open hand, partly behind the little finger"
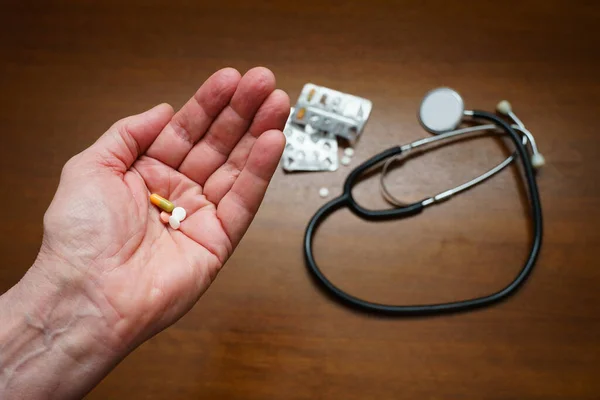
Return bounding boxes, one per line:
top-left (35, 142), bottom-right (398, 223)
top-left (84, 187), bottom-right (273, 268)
top-left (204, 89), bottom-right (290, 204)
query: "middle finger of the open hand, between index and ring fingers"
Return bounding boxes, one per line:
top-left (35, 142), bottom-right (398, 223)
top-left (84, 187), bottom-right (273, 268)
top-left (179, 67), bottom-right (275, 185)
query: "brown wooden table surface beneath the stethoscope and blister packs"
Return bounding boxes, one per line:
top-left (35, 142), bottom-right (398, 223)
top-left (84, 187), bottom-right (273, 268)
top-left (0, 0), bottom-right (600, 400)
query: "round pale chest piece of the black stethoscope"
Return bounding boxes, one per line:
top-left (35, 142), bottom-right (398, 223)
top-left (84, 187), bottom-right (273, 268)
top-left (419, 87), bottom-right (465, 134)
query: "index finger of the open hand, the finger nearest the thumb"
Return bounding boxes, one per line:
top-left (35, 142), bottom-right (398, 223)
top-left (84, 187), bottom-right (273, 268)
top-left (147, 68), bottom-right (240, 168)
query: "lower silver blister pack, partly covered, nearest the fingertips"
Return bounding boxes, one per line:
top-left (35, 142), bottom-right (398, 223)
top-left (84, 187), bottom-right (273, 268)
top-left (281, 124), bottom-right (338, 171)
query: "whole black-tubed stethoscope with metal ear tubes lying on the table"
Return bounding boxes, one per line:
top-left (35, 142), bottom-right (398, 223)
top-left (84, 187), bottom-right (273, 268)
top-left (304, 88), bottom-right (545, 315)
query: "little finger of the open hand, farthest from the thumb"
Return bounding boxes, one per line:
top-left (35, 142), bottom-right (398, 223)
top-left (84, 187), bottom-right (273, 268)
top-left (217, 130), bottom-right (285, 247)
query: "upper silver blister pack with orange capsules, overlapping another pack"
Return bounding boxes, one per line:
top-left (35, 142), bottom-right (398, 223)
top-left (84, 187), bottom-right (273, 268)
top-left (291, 83), bottom-right (373, 141)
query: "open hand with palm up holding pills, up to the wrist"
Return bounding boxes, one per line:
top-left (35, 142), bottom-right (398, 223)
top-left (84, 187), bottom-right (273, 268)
top-left (40, 68), bottom-right (289, 342)
